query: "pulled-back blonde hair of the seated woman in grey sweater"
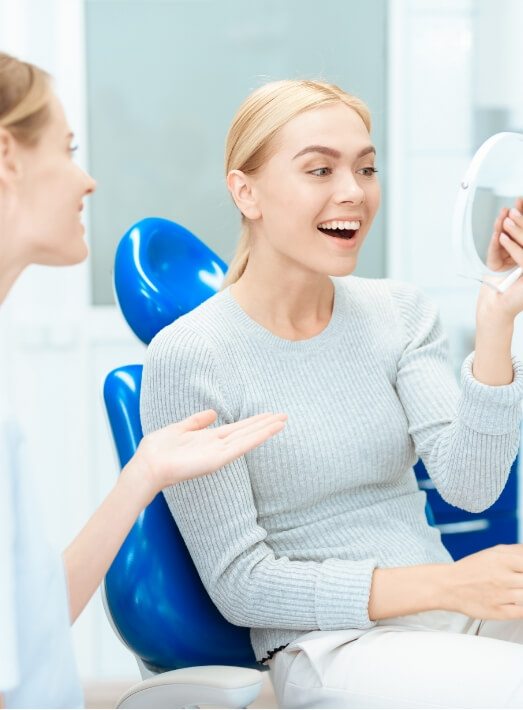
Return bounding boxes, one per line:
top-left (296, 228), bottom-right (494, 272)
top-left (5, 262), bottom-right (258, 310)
top-left (223, 79), bottom-right (371, 288)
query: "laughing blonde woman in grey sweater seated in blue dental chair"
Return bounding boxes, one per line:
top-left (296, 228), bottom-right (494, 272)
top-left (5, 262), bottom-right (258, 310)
top-left (142, 80), bottom-right (523, 707)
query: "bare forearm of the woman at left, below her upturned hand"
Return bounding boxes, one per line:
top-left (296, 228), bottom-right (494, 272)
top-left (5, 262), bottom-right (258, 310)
top-left (63, 465), bottom-right (154, 623)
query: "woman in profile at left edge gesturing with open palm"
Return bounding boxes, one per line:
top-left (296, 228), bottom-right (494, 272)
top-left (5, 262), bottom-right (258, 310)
top-left (0, 53), bottom-right (285, 708)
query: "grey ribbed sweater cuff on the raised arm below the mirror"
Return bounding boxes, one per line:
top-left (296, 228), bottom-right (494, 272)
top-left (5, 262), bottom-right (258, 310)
top-left (459, 352), bottom-right (523, 434)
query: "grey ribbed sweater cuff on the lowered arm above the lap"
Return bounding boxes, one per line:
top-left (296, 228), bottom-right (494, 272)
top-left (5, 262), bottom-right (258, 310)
top-left (316, 559), bottom-right (377, 631)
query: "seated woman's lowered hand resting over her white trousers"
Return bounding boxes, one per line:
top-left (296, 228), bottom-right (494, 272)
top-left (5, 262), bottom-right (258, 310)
top-left (445, 544), bottom-right (523, 619)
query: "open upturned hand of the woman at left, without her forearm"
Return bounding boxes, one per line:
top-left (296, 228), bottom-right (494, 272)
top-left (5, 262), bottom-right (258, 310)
top-left (126, 409), bottom-right (287, 500)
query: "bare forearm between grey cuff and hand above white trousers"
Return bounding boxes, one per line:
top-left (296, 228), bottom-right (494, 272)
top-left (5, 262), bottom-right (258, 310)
top-left (369, 563), bottom-right (451, 621)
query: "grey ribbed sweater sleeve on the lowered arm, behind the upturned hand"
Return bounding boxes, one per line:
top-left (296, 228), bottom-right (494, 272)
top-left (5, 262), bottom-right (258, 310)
top-left (141, 323), bottom-right (376, 631)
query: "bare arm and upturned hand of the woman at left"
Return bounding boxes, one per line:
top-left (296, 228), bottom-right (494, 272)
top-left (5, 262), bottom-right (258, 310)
top-left (63, 410), bottom-right (285, 622)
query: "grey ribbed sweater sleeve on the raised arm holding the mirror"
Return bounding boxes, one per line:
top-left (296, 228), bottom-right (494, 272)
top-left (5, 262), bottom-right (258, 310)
top-left (393, 286), bottom-right (523, 512)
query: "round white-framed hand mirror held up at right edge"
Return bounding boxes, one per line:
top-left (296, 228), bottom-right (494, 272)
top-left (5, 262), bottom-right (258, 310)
top-left (453, 132), bottom-right (523, 291)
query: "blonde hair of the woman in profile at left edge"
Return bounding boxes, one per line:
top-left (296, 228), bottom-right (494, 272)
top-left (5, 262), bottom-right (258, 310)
top-left (0, 52), bottom-right (52, 145)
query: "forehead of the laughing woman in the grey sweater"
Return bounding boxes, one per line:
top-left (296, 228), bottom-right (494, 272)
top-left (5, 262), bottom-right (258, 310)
top-left (277, 103), bottom-right (370, 156)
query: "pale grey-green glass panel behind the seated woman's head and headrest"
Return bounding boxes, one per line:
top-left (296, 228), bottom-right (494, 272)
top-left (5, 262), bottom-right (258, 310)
top-left (86, 0), bottom-right (386, 305)
